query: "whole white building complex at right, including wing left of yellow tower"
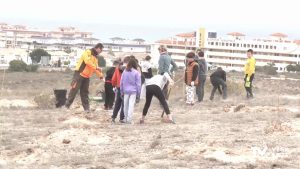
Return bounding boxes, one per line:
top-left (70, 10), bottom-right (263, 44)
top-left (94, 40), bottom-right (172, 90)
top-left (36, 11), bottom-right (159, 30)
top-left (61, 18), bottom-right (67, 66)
top-left (157, 28), bottom-right (300, 72)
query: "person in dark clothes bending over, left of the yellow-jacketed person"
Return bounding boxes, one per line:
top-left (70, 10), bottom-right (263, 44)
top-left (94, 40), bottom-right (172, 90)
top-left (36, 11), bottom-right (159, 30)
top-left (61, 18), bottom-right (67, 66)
top-left (210, 67), bottom-right (227, 100)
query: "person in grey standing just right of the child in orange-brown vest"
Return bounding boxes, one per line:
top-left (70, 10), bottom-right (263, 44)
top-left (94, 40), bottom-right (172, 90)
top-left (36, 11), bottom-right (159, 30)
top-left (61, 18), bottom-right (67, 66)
top-left (196, 50), bottom-right (207, 102)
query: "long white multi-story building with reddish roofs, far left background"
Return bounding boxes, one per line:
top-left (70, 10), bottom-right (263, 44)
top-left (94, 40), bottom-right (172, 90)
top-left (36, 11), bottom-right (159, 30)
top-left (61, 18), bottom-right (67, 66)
top-left (0, 23), bottom-right (99, 50)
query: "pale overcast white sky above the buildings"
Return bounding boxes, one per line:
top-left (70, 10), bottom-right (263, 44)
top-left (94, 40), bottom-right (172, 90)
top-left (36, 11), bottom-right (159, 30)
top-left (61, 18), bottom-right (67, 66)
top-left (0, 0), bottom-right (300, 41)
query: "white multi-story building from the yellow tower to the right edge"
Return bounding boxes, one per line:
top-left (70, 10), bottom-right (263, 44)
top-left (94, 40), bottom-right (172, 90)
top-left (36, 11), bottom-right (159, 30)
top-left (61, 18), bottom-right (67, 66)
top-left (197, 29), bottom-right (300, 72)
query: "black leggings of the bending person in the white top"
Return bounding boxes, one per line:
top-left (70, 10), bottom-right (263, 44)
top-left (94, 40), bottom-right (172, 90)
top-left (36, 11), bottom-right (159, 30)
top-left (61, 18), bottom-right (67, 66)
top-left (143, 85), bottom-right (170, 116)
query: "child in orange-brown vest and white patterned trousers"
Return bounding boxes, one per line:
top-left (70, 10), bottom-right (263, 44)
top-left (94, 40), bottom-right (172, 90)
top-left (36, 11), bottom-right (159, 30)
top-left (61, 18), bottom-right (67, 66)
top-left (184, 52), bottom-right (199, 105)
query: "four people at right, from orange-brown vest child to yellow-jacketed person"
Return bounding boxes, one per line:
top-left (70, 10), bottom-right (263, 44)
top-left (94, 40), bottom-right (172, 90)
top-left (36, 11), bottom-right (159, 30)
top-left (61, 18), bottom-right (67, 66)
top-left (185, 49), bottom-right (256, 105)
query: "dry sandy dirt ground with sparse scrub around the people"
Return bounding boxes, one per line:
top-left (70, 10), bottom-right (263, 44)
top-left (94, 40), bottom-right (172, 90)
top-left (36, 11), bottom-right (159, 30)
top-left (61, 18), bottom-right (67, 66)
top-left (0, 72), bottom-right (300, 169)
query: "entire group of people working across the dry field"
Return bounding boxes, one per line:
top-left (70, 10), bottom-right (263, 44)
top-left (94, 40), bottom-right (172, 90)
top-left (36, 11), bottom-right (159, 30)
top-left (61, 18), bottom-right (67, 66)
top-left (65, 43), bottom-right (255, 123)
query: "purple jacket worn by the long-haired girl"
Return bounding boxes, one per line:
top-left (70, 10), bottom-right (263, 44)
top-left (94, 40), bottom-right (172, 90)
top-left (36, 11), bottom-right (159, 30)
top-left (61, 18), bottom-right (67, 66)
top-left (120, 68), bottom-right (141, 95)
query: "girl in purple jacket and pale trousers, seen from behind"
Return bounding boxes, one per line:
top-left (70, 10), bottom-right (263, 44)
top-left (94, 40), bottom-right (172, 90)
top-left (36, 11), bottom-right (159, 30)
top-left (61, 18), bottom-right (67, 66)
top-left (120, 59), bottom-right (141, 123)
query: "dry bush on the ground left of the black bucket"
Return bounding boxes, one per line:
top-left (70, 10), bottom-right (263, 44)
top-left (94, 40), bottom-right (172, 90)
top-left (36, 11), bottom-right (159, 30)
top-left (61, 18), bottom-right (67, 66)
top-left (34, 94), bottom-right (55, 109)
